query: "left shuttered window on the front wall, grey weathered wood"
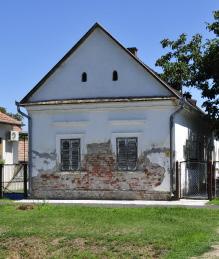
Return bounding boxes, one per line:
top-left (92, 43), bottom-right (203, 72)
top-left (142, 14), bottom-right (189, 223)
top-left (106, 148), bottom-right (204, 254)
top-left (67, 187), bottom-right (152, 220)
top-left (61, 139), bottom-right (81, 171)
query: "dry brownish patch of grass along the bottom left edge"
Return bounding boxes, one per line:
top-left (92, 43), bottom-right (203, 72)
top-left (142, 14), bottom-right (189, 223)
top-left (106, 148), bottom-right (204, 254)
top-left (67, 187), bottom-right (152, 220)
top-left (0, 237), bottom-right (164, 259)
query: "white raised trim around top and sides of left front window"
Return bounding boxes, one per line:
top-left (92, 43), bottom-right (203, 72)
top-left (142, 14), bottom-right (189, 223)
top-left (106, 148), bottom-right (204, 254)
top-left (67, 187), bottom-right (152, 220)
top-left (56, 133), bottom-right (85, 166)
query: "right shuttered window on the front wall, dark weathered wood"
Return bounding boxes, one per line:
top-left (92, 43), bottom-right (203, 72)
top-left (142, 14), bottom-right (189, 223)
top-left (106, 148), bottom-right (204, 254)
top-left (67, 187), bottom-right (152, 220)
top-left (116, 138), bottom-right (138, 171)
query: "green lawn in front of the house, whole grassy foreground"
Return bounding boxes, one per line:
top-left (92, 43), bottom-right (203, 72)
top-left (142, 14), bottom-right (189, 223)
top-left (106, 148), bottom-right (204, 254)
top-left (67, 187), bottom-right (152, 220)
top-left (0, 204), bottom-right (219, 259)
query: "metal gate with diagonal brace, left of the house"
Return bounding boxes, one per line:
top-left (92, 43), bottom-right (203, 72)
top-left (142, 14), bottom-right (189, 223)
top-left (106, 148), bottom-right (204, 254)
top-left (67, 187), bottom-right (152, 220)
top-left (0, 163), bottom-right (28, 199)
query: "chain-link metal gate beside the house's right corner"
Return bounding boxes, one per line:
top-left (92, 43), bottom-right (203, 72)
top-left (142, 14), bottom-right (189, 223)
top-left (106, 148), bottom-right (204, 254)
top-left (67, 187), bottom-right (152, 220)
top-left (179, 161), bottom-right (208, 199)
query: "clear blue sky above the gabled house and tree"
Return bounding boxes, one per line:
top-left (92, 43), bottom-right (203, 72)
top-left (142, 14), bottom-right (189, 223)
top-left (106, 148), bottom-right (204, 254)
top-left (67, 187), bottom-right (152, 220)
top-left (0, 0), bottom-right (219, 118)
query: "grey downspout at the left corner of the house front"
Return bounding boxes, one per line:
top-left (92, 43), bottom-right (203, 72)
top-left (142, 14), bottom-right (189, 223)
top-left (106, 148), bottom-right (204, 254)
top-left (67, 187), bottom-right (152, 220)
top-left (15, 101), bottom-right (32, 197)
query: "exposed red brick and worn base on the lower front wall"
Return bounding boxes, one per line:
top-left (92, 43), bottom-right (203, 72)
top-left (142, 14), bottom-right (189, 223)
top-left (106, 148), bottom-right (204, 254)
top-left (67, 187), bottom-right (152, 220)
top-left (32, 141), bottom-right (170, 200)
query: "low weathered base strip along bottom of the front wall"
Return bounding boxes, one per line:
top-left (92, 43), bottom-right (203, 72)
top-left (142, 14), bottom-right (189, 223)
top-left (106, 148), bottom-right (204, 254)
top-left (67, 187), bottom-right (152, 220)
top-left (31, 189), bottom-right (171, 200)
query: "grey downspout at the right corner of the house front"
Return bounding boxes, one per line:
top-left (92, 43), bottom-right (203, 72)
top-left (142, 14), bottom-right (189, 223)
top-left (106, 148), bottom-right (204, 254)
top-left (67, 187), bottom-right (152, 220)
top-left (170, 97), bottom-right (185, 197)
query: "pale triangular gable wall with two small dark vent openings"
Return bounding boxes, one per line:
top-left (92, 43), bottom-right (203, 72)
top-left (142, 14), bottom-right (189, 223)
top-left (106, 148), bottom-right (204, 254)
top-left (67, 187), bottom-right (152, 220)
top-left (30, 29), bottom-right (172, 101)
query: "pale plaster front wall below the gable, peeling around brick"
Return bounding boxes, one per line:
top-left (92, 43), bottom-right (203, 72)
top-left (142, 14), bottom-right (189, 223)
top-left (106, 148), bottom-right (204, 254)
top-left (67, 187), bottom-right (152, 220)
top-left (28, 101), bottom-right (175, 191)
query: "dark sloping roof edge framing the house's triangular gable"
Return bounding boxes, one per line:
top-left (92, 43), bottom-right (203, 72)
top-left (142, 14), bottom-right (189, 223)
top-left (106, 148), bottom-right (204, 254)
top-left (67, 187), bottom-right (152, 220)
top-left (20, 23), bottom-right (181, 106)
